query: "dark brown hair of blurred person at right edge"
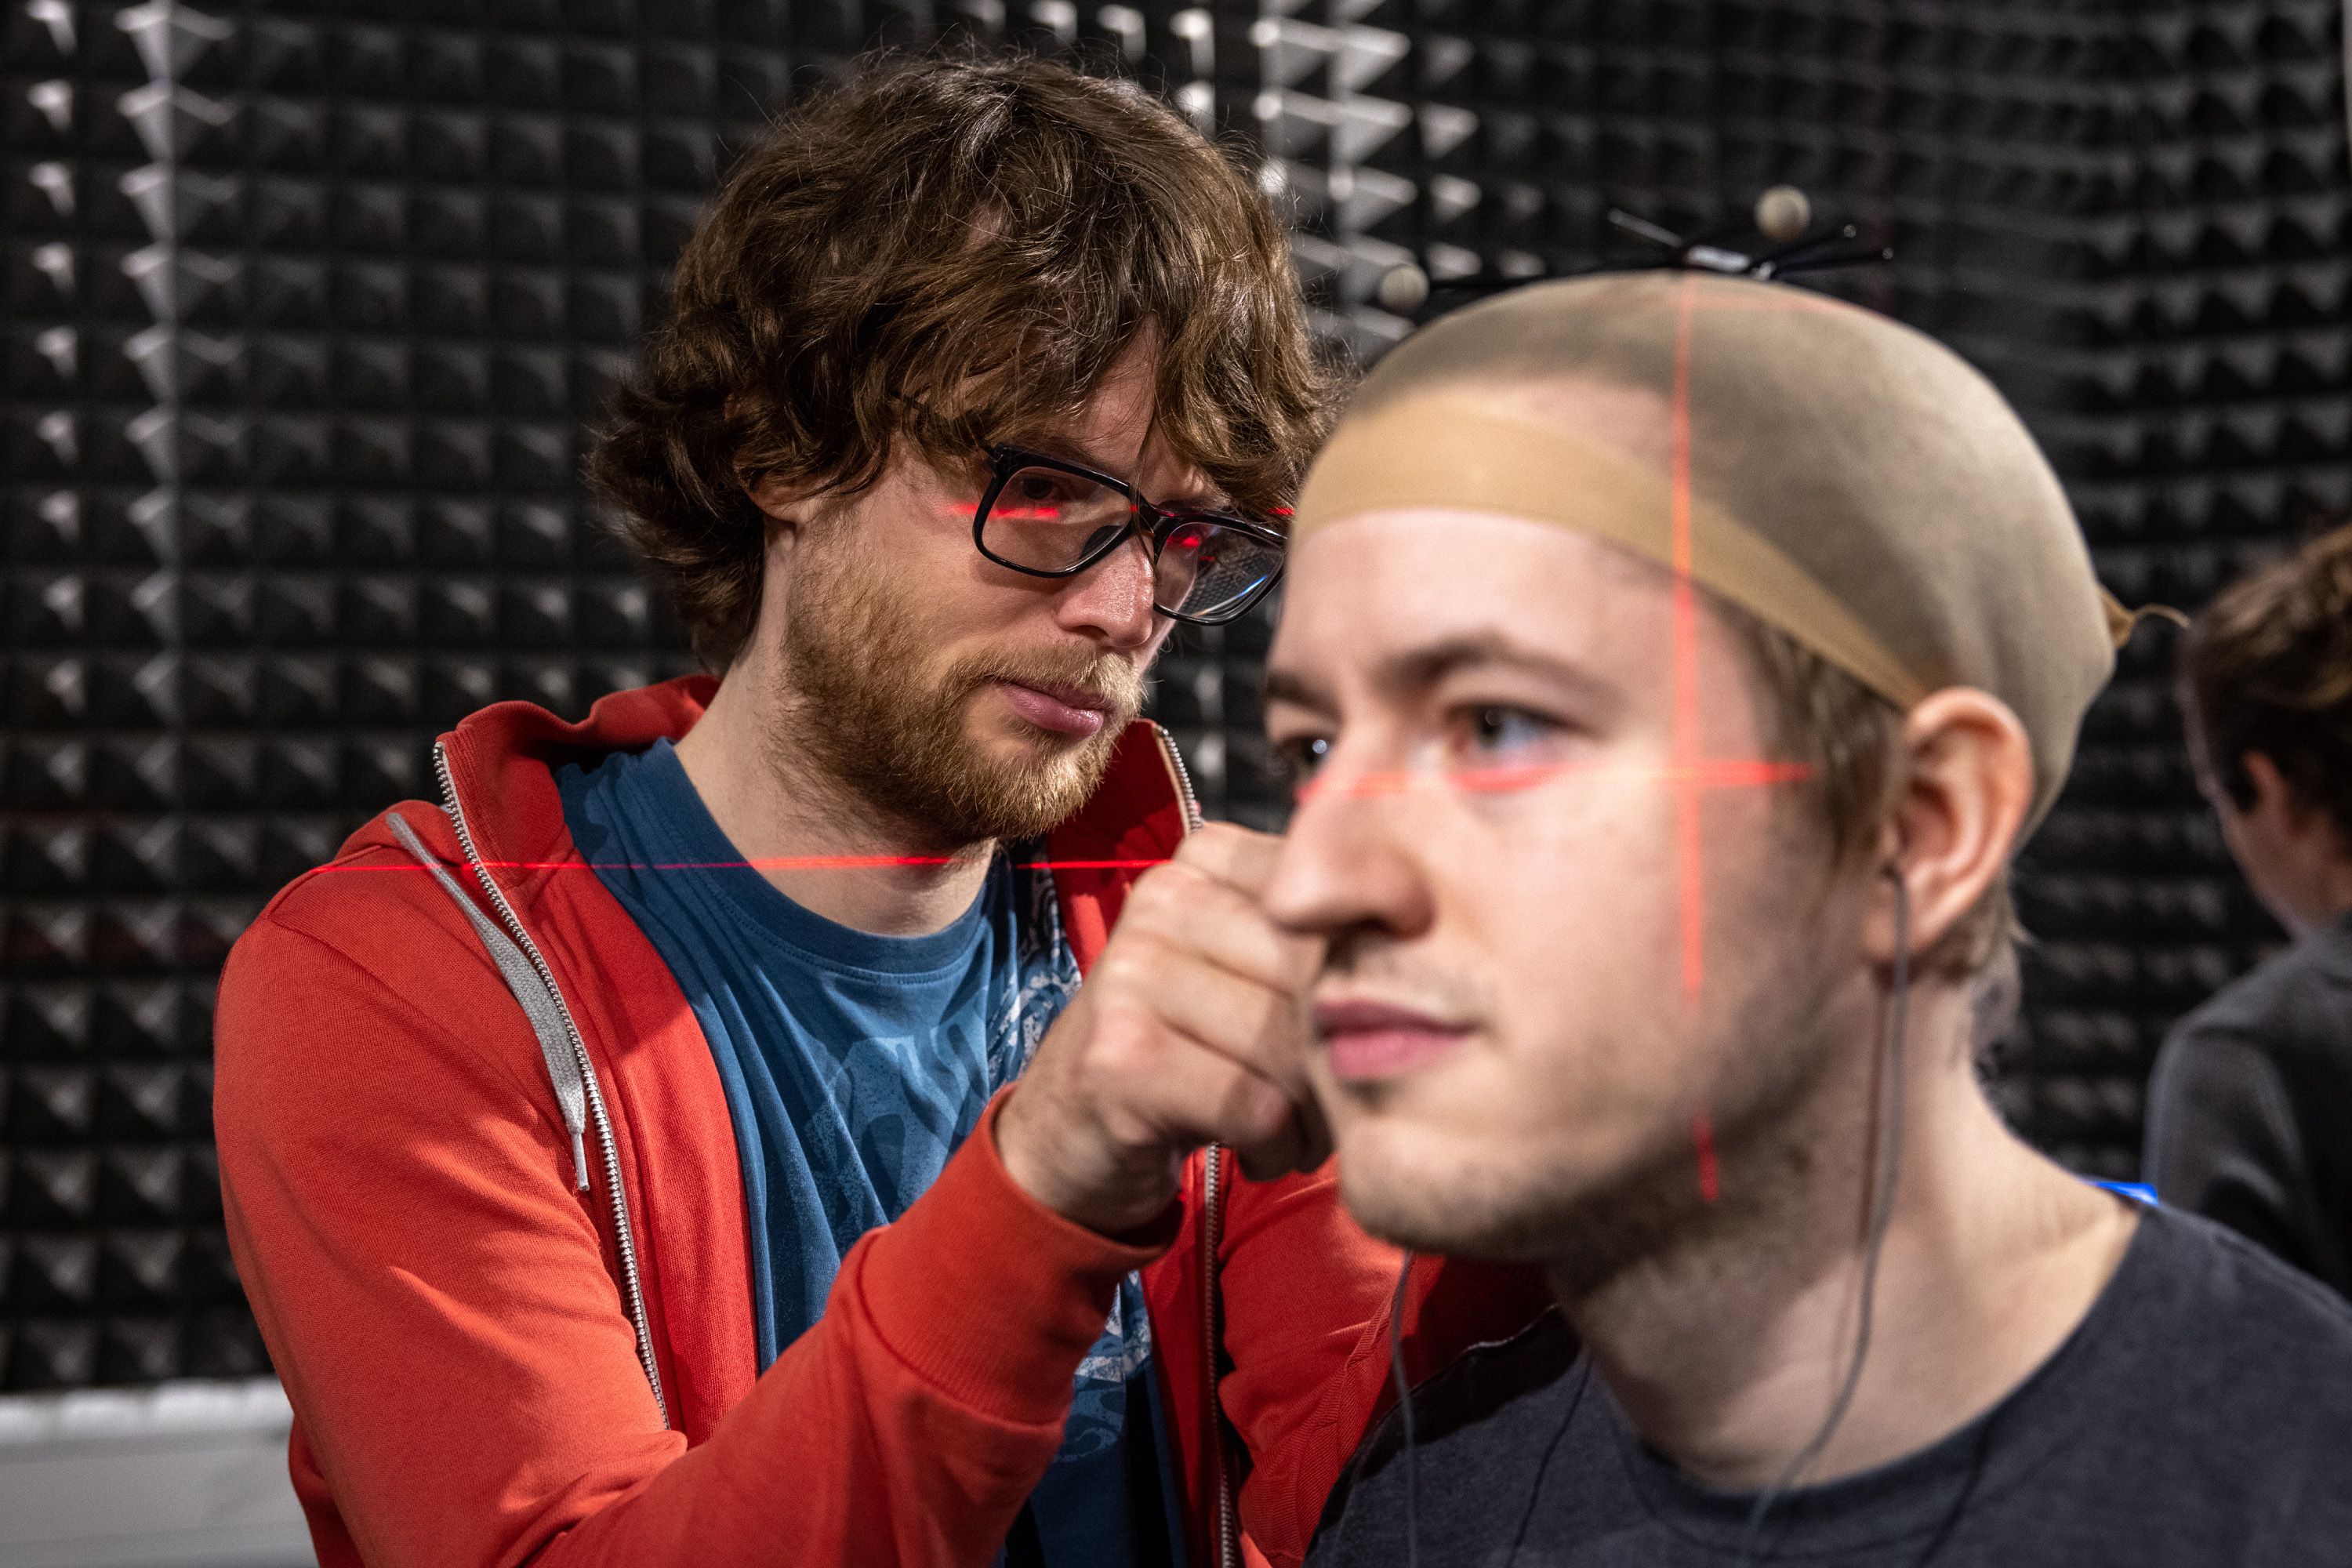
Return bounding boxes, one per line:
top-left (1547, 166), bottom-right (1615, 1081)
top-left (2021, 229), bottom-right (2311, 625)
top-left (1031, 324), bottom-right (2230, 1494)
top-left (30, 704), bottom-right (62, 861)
top-left (2180, 524), bottom-right (2352, 844)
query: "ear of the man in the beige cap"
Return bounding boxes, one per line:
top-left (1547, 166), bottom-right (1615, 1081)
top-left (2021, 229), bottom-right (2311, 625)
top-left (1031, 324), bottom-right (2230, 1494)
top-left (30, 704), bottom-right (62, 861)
top-left (1863, 687), bottom-right (2034, 964)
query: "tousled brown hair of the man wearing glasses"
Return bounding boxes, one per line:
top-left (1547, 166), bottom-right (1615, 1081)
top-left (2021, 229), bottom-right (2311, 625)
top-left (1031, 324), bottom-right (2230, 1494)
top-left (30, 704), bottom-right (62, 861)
top-left (588, 56), bottom-right (1338, 670)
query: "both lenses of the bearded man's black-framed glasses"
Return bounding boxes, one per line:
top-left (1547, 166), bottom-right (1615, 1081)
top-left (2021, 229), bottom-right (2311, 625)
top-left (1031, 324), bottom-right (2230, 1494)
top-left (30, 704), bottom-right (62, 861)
top-left (981, 468), bottom-right (1282, 619)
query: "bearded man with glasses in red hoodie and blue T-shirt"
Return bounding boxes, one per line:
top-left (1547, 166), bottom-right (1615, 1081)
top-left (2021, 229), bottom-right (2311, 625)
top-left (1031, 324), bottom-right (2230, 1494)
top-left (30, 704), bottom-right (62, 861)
top-left (216, 64), bottom-right (1524, 1568)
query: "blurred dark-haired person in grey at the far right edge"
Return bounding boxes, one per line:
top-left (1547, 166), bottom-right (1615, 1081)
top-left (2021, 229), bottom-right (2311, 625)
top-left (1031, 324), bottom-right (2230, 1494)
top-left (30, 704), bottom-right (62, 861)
top-left (2147, 524), bottom-right (2352, 1295)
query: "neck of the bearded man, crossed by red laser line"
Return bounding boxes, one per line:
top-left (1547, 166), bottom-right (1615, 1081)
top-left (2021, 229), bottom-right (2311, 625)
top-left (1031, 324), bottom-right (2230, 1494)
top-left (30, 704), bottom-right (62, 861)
top-left (677, 661), bottom-right (995, 935)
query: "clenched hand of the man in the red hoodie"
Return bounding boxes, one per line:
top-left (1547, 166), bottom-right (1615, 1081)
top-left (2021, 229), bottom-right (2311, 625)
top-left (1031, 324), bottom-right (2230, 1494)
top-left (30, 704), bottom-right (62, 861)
top-left (997, 822), bottom-right (1331, 1234)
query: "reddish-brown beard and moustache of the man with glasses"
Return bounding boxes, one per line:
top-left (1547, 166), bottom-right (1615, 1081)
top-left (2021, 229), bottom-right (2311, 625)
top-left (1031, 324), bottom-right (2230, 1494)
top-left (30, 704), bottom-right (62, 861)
top-left (783, 562), bottom-right (1143, 851)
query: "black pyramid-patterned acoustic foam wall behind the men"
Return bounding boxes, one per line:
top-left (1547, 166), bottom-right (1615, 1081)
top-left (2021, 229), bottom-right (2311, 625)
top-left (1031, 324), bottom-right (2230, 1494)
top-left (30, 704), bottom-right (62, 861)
top-left (0, 0), bottom-right (2352, 1389)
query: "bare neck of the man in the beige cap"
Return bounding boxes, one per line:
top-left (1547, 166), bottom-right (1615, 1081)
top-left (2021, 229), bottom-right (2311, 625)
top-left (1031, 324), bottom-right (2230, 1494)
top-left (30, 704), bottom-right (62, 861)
top-left (1555, 987), bottom-right (2136, 1490)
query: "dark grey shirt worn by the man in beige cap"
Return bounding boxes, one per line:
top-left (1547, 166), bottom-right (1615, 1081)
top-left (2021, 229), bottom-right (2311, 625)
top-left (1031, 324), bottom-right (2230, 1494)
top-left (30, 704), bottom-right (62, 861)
top-left (1308, 1208), bottom-right (2352, 1568)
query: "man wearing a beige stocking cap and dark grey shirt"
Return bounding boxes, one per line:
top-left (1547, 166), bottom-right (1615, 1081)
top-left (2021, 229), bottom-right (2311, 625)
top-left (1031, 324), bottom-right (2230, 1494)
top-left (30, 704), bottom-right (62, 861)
top-left (1263, 275), bottom-right (2352, 1568)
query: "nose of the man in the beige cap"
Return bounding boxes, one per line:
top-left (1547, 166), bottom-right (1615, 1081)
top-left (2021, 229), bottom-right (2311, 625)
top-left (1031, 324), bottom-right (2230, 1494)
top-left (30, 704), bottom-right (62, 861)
top-left (1263, 753), bottom-right (1437, 938)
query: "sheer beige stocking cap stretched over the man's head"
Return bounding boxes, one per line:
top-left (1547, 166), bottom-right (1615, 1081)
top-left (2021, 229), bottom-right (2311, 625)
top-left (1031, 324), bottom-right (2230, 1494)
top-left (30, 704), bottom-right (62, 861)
top-left (1294, 273), bottom-right (2131, 827)
